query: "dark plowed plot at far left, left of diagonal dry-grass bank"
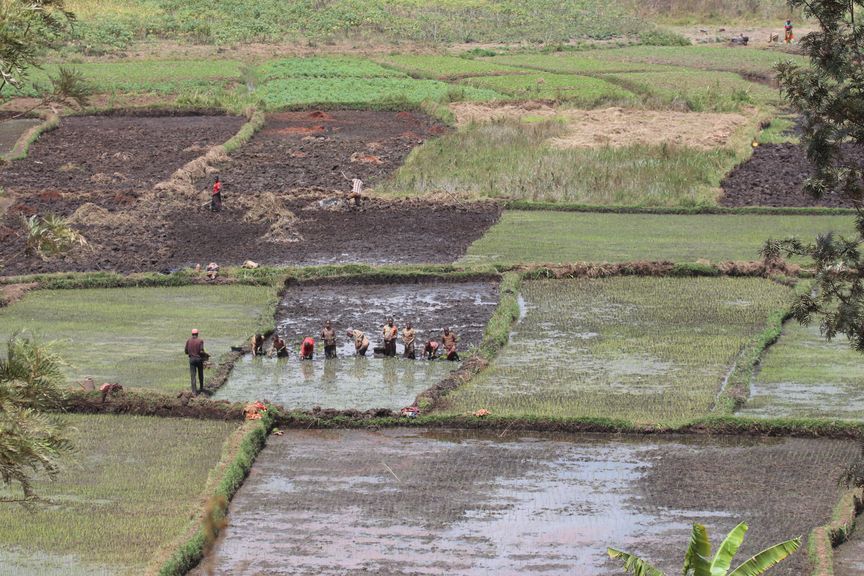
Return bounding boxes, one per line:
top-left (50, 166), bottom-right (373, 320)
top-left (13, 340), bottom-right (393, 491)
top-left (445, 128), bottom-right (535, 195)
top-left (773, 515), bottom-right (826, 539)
top-left (0, 116), bottom-right (245, 196)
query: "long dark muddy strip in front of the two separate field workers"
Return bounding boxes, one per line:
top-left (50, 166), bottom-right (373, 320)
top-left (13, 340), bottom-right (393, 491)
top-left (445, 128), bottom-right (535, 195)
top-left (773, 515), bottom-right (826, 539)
top-left (0, 194), bottom-right (500, 274)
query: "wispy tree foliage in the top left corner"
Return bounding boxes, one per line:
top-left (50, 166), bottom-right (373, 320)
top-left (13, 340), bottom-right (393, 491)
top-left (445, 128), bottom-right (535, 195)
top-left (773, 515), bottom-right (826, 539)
top-left (0, 0), bottom-right (90, 106)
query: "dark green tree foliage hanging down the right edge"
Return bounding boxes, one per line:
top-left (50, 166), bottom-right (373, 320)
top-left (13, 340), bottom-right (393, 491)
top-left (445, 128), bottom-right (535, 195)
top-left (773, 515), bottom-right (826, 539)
top-left (763, 0), bottom-right (864, 352)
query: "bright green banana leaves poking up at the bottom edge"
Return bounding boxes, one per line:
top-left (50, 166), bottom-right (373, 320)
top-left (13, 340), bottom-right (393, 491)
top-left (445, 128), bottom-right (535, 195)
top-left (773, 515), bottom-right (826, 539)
top-left (608, 522), bottom-right (801, 576)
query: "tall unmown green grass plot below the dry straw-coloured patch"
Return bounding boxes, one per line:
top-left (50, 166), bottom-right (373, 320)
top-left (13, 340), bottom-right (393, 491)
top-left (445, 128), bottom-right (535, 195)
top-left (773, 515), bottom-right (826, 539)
top-left (377, 120), bottom-right (739, 206)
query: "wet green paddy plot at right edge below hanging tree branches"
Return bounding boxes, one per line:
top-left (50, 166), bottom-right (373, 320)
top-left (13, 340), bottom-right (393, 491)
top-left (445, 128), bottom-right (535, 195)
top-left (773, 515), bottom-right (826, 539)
top-left (738, 321), bottom-right (864, 420)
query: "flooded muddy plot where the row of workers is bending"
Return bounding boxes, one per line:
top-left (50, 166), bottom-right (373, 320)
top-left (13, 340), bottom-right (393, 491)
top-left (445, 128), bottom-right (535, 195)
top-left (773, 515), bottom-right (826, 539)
top-left (215, 279), bottom-right (498, 410)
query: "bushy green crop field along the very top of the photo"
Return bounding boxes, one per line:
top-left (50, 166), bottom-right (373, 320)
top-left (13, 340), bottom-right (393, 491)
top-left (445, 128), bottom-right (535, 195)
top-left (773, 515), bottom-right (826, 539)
top-left (67, 0), bottom-right (644, 53)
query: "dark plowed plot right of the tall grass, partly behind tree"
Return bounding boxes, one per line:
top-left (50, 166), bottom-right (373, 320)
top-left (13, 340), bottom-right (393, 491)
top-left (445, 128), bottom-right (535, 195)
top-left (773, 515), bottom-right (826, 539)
top-left (720, 144), bottom-right (864, 208)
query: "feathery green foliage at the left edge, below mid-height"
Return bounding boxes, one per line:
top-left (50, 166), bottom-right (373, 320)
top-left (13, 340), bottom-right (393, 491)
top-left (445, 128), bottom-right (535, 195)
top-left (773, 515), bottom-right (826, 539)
top-left (0, 335), bottom-right (72, 503)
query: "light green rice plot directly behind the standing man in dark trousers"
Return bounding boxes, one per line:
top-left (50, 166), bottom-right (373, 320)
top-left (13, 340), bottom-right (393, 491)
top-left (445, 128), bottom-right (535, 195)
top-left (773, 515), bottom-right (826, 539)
top-left (0, 286), bottom-right (276, 390)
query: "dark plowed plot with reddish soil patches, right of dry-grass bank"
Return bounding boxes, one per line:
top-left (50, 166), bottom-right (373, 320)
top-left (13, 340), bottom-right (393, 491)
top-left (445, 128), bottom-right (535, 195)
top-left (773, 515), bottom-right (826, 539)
top-left (197, 111), bottom-right (446, 196)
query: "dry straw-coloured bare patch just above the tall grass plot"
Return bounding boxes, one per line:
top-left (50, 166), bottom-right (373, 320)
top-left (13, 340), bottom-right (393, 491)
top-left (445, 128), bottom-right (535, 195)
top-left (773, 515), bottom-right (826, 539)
top-left (450, 102), bottom-right (749, 150)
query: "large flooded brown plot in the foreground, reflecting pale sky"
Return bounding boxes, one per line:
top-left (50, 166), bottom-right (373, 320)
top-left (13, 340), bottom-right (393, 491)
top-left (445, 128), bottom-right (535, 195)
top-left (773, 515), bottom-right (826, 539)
top-left (198, 429), bottom-right (858, 576)
